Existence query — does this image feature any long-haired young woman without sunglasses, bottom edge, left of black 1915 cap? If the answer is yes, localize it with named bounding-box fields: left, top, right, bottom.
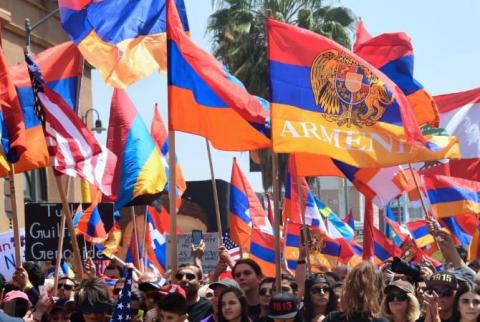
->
left=218, top=287, right=250, bottom=322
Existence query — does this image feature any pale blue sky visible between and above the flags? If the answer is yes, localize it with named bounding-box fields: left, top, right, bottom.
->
left=92, top=0, right=480, bottom=191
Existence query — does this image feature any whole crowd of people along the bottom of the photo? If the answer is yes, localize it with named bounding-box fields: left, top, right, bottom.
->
left=0, top=226, right=480, bottom=322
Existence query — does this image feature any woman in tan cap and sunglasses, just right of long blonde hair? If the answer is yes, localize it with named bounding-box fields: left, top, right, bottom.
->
left=381, top=280, right=420, bottom=322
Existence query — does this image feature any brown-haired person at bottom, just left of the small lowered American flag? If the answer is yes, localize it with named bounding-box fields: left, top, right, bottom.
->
left=75, top=277, right=114, bottom=322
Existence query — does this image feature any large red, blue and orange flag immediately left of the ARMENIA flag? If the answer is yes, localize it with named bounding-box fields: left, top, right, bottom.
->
left=168, top=0, right=270, bottom=151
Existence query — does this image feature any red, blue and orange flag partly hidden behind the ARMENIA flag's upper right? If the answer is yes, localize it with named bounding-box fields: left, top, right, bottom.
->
left=353, top=20, right=439, bottom=127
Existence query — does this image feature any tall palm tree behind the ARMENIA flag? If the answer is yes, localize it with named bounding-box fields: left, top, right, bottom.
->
left=207, top=0, right=355, bottom=190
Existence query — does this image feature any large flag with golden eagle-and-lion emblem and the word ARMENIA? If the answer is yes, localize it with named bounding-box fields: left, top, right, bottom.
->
left=267, top=19, right=459, bottom=168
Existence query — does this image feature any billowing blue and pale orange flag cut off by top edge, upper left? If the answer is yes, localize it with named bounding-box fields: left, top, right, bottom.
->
left=58, top=0, right=188, bottom=88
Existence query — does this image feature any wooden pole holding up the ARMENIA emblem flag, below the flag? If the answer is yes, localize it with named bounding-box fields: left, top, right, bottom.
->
left=272, top=150, right=282, bottom=292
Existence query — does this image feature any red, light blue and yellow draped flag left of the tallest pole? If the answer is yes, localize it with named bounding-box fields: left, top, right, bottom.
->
left=107, top=89, right=167, bottom=209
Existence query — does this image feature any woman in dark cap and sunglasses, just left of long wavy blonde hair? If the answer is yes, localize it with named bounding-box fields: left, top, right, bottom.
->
left=303, top=273, right=338, bottom=322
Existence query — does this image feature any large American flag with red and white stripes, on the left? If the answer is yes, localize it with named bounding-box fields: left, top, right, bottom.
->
left=25, top=54, right=117, bottom=196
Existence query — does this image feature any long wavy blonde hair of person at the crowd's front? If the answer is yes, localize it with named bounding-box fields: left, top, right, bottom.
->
left=340, top=262, right=381, bottom=319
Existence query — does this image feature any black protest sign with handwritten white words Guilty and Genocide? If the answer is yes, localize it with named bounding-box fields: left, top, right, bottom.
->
left=25, top=203, right=113, bottom=261
